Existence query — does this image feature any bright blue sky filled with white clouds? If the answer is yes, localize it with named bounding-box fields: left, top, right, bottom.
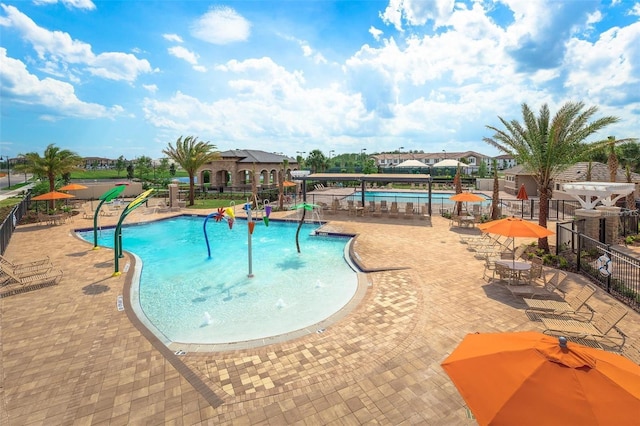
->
left=0, top=0, right=640, bottom=159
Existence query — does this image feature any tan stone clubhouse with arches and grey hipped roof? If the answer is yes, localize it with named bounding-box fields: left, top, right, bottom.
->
left=196, top=149, right=298, bottom=188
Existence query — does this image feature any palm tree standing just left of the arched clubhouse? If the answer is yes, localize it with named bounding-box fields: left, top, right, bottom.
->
left=162, top=136, right=220, bottom=206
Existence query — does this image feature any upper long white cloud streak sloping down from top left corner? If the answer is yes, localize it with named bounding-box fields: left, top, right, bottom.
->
left=0, top=4, right=152, bottom=82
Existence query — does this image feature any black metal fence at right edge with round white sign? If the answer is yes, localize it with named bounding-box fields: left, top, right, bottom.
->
left=556, top=220, right=640, bottom=312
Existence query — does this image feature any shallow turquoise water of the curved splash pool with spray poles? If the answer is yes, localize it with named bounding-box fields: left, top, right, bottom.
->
left=79, top=216, right=357, bottom=344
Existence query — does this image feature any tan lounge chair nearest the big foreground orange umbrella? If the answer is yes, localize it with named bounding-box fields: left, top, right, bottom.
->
left=541, top=302, right=628, bottom=351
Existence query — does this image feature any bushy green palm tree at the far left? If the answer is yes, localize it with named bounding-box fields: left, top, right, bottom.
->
left=16, top=144, right=82, bottom=209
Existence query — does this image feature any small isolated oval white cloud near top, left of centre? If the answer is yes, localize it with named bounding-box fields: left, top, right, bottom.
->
left=191, top=7, right=251, bottom=44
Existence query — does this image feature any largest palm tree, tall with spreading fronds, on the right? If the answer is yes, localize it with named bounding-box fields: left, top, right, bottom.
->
left=483, top=102, right=619, bottom=252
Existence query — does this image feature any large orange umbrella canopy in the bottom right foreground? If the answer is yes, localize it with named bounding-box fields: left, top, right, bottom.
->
left=442, top=332, right=640, bottom=425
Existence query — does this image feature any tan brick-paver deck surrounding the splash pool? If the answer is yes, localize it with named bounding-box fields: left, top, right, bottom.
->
left=0, top=202, right=640, bottom=426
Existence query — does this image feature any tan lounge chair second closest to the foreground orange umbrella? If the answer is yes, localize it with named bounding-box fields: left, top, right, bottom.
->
left=524, top=282, right=596, bottom=320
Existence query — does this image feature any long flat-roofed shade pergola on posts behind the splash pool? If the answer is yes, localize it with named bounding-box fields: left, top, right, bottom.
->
left=294, top=173, right=431, bottom=215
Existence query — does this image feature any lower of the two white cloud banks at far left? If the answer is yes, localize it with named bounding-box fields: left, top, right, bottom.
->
left=0, top=47, right=123, bottom=118
